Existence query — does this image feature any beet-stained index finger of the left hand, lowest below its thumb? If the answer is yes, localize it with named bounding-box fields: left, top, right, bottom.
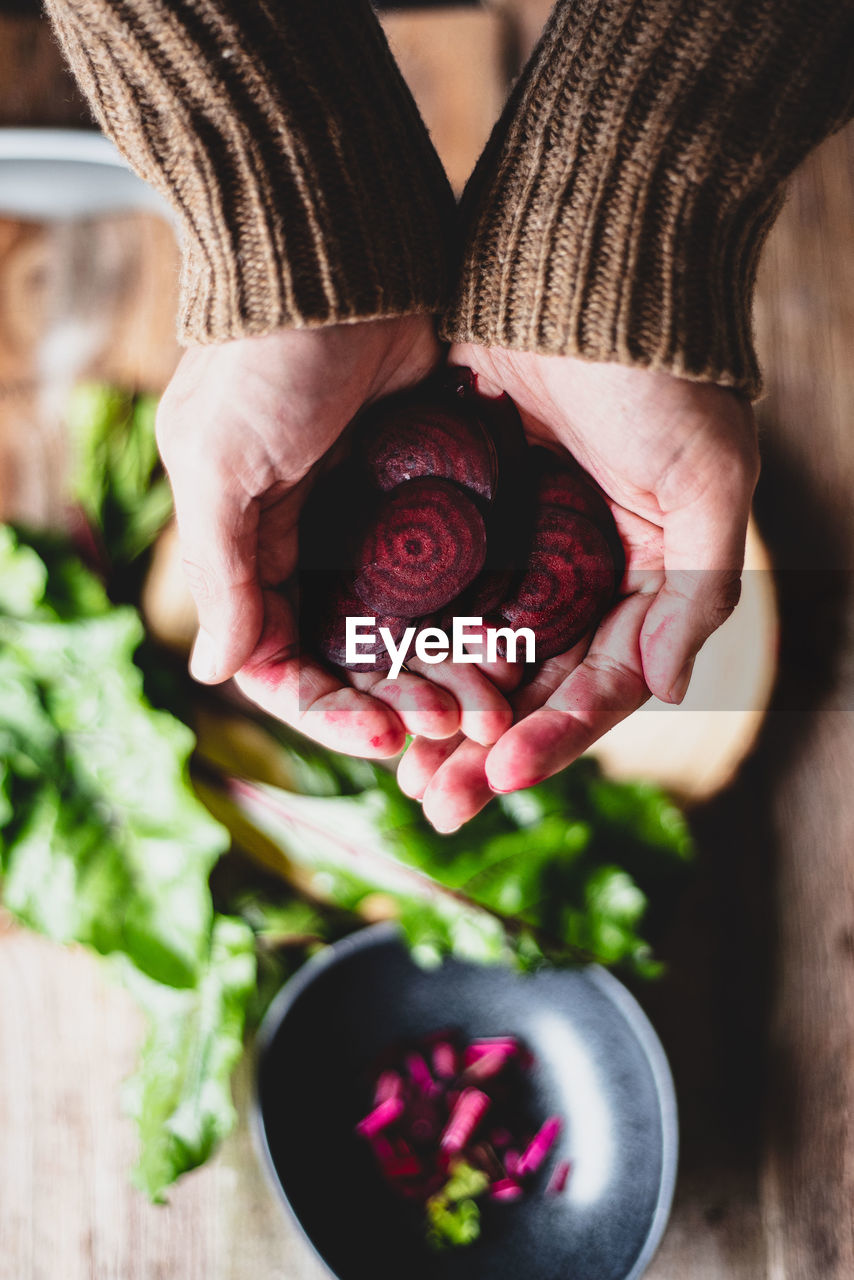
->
left=234, top=591, right=406, bottom=759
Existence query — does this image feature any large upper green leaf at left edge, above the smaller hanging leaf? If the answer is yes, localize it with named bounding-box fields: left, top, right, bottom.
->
left=0, top=535, right=228, bottom=986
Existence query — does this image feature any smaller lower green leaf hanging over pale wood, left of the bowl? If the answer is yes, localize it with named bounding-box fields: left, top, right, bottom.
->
left=123, top=916, right=256, bottom=1202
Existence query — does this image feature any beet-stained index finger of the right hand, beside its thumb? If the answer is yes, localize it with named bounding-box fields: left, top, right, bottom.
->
left=485, top=595, right=649, bottom=792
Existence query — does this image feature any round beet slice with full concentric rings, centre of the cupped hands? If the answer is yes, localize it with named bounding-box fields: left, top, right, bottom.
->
left=355, top=479, right=487, bottom=618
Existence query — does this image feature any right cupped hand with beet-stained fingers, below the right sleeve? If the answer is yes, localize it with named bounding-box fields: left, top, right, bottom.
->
left=398, top=346, right=758, bottom=832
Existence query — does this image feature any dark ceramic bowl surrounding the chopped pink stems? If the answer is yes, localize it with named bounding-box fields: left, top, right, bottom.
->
left=250, top=925, right=677, bottom=1280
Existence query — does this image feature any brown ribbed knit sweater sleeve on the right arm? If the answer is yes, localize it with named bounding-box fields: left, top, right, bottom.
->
left=443, top=0, right=854, bottom=396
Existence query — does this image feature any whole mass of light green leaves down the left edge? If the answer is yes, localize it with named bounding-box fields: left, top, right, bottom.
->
left=0, top=526, right=256, bottom=1199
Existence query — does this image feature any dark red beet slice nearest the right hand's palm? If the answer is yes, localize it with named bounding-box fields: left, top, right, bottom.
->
left=498, top=507, right=617, bottom=662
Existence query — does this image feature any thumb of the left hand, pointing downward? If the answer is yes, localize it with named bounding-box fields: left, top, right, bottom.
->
left=170, top=466, right=264, bottom=685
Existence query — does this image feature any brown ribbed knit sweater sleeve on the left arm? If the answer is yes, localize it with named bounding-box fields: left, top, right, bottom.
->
left=41, top=0, right=453, bottom=342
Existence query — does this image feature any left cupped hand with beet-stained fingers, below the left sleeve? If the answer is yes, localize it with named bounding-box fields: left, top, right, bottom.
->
left=157, top=316, right=510, bottom=756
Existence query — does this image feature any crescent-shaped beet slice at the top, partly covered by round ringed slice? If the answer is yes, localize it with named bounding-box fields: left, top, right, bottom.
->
left=359, top=392, right=497, bottom=502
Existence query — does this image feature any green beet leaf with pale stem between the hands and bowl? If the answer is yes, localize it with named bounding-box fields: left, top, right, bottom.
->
left=218, top=727, right=691, bottom=975
